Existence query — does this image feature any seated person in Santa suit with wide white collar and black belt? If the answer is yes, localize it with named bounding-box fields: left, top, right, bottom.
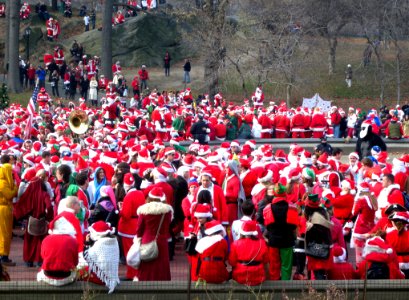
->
left=192, top=221, right=229, bottom=283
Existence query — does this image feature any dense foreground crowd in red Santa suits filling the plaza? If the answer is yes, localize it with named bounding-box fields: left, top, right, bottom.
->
left=0, top=96, right=409, bottom=291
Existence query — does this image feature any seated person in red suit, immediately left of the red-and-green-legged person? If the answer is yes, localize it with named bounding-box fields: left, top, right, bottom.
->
left=229, top=221, right=268, bottom=286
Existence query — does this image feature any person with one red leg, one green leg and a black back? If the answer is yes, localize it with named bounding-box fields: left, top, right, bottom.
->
left=263, top=183, right=299, bottom=280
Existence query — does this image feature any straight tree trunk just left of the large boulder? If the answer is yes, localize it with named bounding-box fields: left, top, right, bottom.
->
left=101, top=0, right=113, bottom=80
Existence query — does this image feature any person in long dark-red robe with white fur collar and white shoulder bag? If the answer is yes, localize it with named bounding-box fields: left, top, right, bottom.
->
left=134, top=187, right=173, bottom=281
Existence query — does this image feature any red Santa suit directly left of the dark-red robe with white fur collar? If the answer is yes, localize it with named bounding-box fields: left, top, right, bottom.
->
left=118, top=189, right=146, bottom=279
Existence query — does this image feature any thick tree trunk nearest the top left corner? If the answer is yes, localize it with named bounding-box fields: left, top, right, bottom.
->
left=7, top=0, right=21, bottom=93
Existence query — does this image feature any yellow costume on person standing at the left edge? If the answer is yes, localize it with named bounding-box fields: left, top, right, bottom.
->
left=0, top=164, right=17, bottom=256
